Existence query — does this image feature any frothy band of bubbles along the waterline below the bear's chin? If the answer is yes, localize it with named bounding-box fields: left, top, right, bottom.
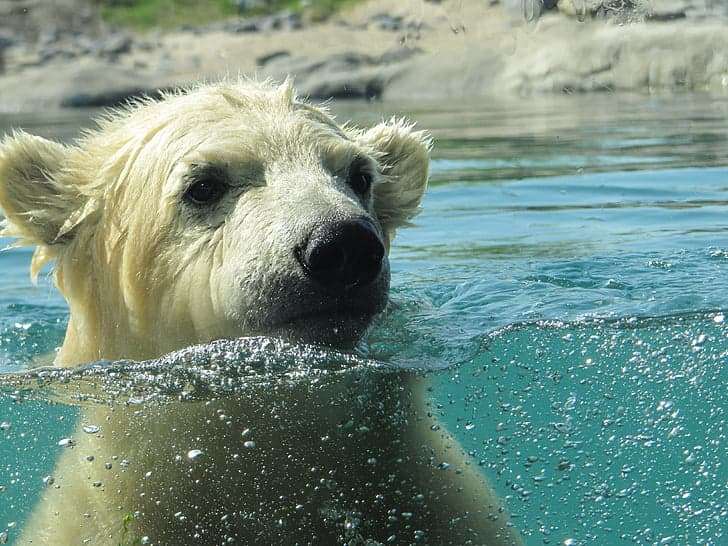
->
left=0, top=337, right=387, bottom=405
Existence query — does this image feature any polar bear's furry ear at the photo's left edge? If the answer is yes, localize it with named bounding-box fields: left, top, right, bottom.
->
left=0, top=131, right=79, bottom=246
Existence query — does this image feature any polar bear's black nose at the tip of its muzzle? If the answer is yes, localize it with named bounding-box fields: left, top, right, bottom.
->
left=298, top=219, right=384, bottom=288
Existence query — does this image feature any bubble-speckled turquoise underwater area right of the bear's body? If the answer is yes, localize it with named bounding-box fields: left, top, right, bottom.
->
left=436, top=311, right=728, bottom=544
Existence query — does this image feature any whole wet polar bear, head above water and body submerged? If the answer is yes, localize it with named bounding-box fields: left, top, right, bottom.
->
left=0, top=80, right=519, bottom=545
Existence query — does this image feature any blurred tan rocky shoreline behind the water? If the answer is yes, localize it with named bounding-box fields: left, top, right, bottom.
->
left=0, top=0, right=728, bottom=112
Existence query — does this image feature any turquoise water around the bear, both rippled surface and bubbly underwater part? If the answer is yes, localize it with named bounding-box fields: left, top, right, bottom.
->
left=0, top=96, right=728, bottom=545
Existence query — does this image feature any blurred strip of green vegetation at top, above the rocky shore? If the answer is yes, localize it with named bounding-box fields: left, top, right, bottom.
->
left=96, top=0, right=361, bottom=30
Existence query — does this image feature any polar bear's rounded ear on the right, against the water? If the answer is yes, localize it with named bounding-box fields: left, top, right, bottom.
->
left=359, top=119, right=432, bottom=238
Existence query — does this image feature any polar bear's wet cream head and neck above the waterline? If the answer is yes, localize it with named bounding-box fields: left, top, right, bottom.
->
left=0, top=81, right=430, bottom=364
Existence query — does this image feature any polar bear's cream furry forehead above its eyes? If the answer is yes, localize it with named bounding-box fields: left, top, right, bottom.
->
left=79, top=86, right=370, bottom=202
